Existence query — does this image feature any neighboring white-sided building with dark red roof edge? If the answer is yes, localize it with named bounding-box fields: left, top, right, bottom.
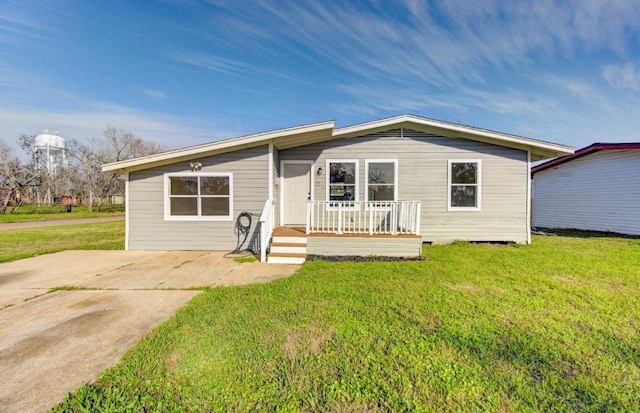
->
left=531, top=143, right=640, bottom=235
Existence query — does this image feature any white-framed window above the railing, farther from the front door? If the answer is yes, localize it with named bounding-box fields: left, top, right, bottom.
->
left=365, top=159, right=398, bottom=201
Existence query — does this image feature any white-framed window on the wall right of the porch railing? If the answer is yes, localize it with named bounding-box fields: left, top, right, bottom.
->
left=448, top=160, right=481, bottom=211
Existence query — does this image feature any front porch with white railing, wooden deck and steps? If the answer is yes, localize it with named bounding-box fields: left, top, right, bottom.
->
left=260, top=201, right=422, bottom=264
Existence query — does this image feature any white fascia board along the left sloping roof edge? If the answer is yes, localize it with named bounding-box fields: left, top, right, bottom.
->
left=102, top=121, right=335, bottom=172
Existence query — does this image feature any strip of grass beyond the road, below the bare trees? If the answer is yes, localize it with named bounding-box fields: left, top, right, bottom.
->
left=0, top=205, right=124, bottom=225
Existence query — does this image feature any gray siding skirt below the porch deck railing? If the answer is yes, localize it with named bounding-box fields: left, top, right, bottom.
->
left=307, top=235, right=422, bottom=257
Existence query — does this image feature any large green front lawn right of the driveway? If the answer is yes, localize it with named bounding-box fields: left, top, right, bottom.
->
left=54, top=237, right=640, bottom=412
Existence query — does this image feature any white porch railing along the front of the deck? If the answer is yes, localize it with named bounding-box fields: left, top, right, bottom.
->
left=307, top=201, right=421, bottom=235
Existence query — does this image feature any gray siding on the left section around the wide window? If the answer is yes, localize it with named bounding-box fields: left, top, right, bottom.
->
left=128, top=145, right=271, bottom=251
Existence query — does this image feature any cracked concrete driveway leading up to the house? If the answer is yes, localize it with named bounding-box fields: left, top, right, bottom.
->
left=0, top=251, right=299, bottom=412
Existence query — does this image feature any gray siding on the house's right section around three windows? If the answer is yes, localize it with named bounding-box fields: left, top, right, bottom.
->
left=280, top=129, right=529, bottom=243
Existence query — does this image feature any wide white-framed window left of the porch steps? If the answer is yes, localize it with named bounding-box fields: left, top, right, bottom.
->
left=164, top=173, right=233, bottom=221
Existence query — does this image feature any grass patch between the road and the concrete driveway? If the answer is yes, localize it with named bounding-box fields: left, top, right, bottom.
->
left=0, top=221, right=124, bottom=263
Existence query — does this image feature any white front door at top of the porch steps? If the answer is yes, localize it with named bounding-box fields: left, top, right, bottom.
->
left=282, top=162, right=311, bottom=225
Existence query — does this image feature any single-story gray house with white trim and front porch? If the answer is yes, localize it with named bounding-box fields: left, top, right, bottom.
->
left=102, top=115, right=573, bottom=262
